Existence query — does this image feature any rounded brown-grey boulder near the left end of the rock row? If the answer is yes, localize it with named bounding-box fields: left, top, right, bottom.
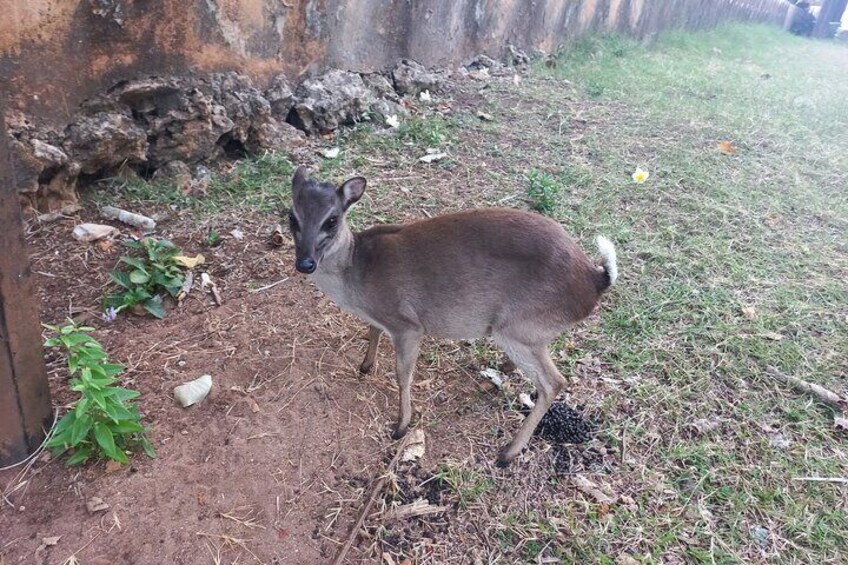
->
left=63, top=112, right=148, bottom=174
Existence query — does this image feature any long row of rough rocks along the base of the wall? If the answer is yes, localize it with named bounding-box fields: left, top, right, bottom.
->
left=7, top=49, right=527, bottom=212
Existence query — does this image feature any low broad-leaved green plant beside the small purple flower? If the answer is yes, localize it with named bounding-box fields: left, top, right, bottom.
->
left=103, top=238, right=183, bottom=318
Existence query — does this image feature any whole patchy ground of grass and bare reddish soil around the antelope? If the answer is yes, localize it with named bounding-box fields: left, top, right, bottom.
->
left=0, top=26, right=848, bottom=565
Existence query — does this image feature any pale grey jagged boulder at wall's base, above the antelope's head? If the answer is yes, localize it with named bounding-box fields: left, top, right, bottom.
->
left=288, top=69, right=374, bottom=133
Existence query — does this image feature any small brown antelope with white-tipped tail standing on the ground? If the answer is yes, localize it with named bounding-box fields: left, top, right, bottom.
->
left=289, top=167, right=618, bottom=467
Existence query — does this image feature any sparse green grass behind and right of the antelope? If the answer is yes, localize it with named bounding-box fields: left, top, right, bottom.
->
left=93, top=25, right=848, bottom=564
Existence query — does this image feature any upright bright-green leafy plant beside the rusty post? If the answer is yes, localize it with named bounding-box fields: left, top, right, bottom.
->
left=44, top=323, right=156, bottom=465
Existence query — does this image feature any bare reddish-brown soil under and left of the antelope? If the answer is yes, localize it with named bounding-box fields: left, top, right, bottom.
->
left=0, top=75, right=617, bottom=565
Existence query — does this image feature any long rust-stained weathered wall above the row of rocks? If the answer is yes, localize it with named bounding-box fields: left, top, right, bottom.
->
left=0, top=0, right=786, bottom=122
